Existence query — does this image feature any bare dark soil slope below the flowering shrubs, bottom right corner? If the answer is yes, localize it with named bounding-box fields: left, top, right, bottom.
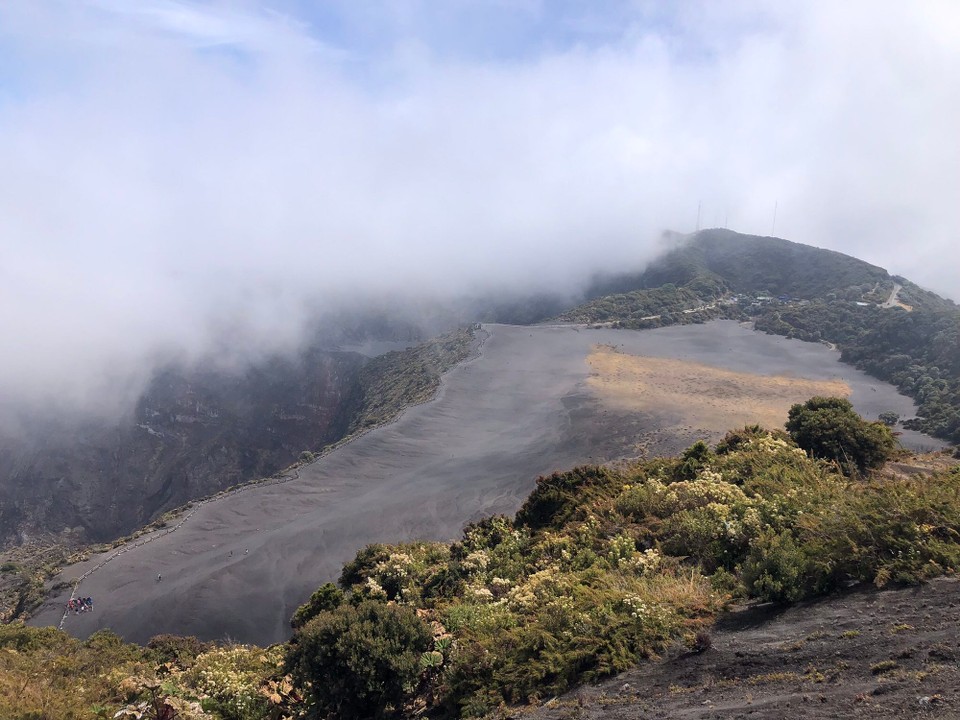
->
left=513, top=579, right=960, bottom=720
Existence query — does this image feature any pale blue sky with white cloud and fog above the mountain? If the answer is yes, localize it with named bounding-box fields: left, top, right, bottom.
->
left=0, top=0, right=960, bottom=420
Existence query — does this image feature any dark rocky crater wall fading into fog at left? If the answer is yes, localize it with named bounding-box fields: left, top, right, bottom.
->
left=0, top=350, right=366, bottom=543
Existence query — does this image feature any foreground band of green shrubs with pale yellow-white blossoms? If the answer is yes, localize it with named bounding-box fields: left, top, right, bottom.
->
left=9, top=414, right=960, bottom=720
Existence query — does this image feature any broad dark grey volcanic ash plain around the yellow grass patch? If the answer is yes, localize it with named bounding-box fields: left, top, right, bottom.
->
left=31, top=321, right=940, bottom=644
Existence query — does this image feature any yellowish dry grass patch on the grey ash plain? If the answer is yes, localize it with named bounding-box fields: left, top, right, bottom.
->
left=587, top=345, right=850, bottom=432
